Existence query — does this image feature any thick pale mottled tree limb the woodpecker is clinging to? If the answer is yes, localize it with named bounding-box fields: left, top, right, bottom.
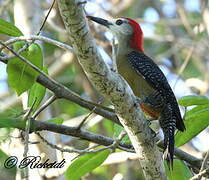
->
left=57, top=0, right=166, bottom=180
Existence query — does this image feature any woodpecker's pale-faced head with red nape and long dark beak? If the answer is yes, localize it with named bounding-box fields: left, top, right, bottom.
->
left=87, top=16, right=144, bottom=52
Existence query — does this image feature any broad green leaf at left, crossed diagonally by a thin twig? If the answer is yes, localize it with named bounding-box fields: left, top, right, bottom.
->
left=7, top=41, right=43, bottom=96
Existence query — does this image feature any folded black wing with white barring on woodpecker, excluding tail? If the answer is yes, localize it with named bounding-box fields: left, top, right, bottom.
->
left=127, top=51, right=185, bottom=131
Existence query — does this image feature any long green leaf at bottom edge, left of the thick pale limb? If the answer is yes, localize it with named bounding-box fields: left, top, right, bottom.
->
left=65, top=149, right=111, bottom=180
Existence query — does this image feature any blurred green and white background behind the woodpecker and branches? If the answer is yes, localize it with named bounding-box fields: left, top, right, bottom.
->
left=0, top=0, right=209, bottom=180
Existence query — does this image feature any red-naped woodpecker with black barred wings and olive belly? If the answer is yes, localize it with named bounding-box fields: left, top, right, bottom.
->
left=87, top=16, right=186, bottom=166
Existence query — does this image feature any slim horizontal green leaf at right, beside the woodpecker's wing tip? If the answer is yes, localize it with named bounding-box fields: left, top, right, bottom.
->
left=178, top=95, right=209, bottom=107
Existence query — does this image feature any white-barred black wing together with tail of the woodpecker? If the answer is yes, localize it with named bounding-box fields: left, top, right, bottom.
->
left=128, top=51, right=185, bottom=166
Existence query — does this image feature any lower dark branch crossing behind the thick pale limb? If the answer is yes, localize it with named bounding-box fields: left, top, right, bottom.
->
left=0, top=117, right=202, bottom=169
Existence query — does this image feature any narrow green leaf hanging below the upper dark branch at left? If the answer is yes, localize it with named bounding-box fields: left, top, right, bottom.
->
left=28, top=67, right=48, bottom=110
